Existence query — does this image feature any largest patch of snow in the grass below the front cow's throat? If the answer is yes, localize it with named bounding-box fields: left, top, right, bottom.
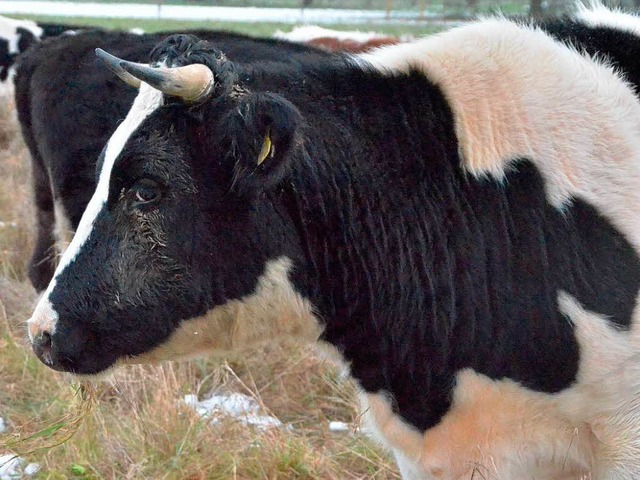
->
left=183, top=393, right=282, bottom=430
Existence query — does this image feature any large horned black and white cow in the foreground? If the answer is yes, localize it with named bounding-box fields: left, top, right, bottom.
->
left=28, top=15, right=640, bottom=480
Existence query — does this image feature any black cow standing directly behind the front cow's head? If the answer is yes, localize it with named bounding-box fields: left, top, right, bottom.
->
left=14, top=30, right=330, bottom=292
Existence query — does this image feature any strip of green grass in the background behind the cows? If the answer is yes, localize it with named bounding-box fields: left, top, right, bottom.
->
left=7, top=15, right=444, bottom=37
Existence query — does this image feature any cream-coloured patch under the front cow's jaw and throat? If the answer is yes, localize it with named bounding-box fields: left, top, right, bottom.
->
left=124, top=257, right=322, bottom=363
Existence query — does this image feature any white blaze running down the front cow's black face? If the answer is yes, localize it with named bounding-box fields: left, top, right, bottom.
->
left=28, top=83, right=163, bottom=339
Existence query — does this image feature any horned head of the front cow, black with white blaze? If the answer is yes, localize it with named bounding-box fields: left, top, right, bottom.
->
left=29, top=36, right=318, bottom=374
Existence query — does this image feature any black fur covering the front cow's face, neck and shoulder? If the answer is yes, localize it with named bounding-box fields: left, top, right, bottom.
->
left=38, top=37, right=640, bottom=430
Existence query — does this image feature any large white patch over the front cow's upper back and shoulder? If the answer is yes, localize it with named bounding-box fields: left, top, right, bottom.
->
left=356, top=18, right=640, bottom=255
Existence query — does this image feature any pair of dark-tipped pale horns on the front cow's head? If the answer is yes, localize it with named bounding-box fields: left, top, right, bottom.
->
left=96, top=49, right=213, bottom=102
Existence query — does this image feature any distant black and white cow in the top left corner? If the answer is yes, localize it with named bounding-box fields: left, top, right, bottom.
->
left=0, top=15, right=88, bottom=85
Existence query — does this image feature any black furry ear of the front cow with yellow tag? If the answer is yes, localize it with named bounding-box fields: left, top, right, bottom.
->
left=224, top=93, right=302, bottom=192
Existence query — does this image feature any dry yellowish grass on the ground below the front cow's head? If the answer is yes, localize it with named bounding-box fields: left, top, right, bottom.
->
left=0, top=92, right=398, bottom=480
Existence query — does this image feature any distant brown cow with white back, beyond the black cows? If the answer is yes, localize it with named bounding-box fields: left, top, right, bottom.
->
left=273, top=25, right=404, bottom=53
